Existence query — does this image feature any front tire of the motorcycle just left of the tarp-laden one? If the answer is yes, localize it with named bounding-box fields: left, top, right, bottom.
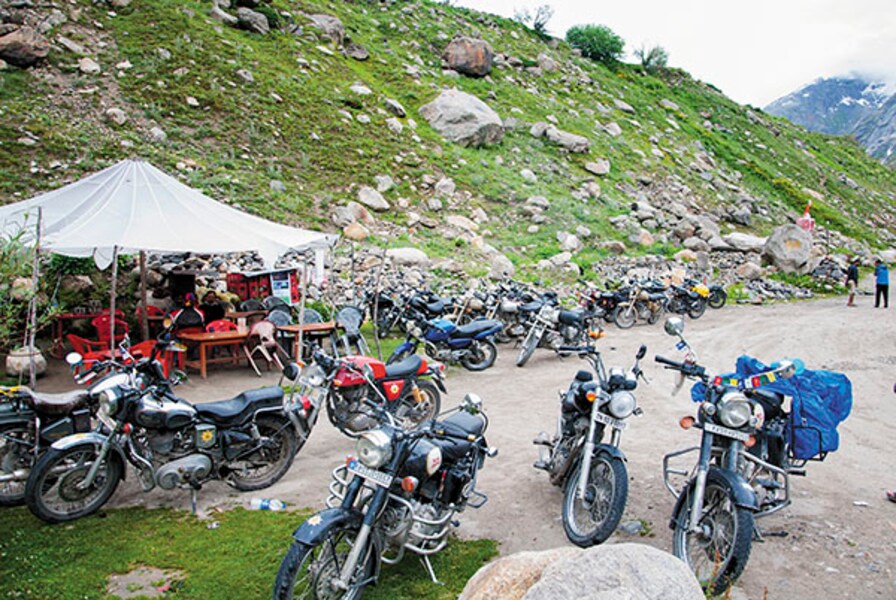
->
left=563, top=453, right=628, bottom=548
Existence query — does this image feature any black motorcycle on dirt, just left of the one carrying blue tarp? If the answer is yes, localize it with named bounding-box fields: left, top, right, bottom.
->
left=533, top=338, right=647, bottom=548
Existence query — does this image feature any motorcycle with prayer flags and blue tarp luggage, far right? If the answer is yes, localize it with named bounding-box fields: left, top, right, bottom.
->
left=656, top=317, right=851, bottom=594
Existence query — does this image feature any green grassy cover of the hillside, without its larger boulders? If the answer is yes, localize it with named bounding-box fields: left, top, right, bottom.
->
left=0, top=0, right=896, bottom=272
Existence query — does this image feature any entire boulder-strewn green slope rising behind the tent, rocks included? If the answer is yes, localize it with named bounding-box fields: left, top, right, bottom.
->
left=0, top=0, right=896, bottom=286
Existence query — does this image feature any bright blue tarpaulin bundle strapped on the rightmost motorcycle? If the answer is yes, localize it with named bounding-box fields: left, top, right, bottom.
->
left=691, top=355, right=852, bottom=460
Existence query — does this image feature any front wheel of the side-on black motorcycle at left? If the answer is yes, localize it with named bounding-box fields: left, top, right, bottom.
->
left=25, top=442, right=124, bottom=523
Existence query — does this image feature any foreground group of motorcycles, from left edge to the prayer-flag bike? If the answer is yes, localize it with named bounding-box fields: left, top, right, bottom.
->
left=0, top=294, right=844, bottom=598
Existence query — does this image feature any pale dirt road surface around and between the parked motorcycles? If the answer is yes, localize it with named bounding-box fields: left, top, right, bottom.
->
left=43, top=298, right=896, bottom=599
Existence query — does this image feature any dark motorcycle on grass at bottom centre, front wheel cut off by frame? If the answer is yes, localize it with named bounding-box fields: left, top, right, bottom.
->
left=273, top=394, right=497, bottom=599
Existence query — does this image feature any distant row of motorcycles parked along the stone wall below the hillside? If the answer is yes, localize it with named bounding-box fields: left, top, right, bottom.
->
left=365, top=279, right=727, bottom=371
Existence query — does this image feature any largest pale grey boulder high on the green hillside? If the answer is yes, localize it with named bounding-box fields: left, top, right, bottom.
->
left=420, top=89, right=504, bottom=146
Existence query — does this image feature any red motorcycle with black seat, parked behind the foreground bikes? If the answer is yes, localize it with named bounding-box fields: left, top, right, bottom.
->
left=298, top=350, right=446, bottom=437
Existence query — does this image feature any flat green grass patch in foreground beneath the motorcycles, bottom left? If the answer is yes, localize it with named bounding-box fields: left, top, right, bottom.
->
left=0, top=508, right=497, bottom=599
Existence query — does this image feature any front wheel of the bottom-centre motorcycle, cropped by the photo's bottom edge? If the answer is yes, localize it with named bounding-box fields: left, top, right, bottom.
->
left=274, top=527, right=379, bottom=600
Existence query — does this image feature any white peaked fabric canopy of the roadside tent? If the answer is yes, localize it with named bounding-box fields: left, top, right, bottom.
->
left=0, top=160, right=336, bottom=267
